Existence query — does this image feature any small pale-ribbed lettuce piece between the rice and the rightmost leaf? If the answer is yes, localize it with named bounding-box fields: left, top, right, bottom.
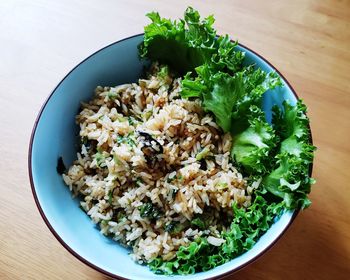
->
left=231, top=105, right=276, bottom=174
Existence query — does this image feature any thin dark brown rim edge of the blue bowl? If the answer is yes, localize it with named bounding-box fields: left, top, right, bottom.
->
left=28, top=33, right=313, bottom=280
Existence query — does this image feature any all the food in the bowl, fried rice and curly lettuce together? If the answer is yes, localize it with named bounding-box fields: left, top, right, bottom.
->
left=59, top=8, right=315, bottom=275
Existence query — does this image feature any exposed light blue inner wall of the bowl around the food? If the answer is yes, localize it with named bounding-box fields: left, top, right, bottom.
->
left=29, top=35, right=296, bottom=279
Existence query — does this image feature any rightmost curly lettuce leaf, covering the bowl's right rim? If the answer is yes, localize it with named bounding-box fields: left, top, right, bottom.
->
left=262, top=100, right=316, bottom=209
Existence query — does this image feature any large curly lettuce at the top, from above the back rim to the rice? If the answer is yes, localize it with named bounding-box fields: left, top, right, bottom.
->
left=139, top=7, right=281, bottom=132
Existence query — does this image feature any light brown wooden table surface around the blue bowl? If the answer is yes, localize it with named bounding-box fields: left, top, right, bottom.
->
left=0, top=0, right=350, bottom=280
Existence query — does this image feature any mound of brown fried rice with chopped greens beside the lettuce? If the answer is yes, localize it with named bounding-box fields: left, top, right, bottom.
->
left=63, top=65, right=258, bottom=263
